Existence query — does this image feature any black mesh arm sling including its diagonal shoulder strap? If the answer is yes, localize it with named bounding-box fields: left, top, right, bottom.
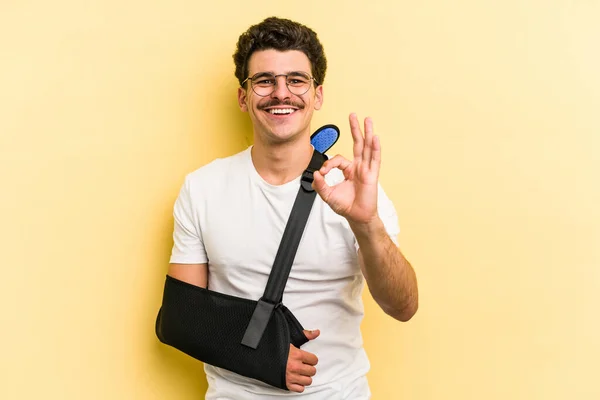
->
left=155, top=150, right=326, bottom=390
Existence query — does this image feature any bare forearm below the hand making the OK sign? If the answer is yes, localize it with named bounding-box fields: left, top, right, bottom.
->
left=350, top=218, right=418, bottom=321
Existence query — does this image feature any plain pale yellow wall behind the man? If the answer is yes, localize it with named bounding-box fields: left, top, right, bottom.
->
left=0, top=0, right=600, bottom=400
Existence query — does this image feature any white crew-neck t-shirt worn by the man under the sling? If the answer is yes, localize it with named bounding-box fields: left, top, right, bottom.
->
left=170, top=146, right=399, bottom=400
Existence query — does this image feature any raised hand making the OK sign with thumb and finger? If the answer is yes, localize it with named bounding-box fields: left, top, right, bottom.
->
left=313, top=113, right=381, bottom=223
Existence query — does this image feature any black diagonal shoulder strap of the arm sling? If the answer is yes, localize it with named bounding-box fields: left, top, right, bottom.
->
left=242, top=150, right=327, bottom=349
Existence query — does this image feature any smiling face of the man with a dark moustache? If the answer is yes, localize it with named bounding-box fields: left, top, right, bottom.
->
left=238, top=50, right=323, bottom=144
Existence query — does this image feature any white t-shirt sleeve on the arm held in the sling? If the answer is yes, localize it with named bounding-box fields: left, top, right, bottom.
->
left=170, top=176, right=208, bottom=264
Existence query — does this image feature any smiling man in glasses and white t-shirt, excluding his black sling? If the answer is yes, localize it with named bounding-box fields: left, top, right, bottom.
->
left=168, top=18, right=418, bottom=400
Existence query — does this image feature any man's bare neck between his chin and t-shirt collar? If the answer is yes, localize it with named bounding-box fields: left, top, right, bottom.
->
left=251, top=137, right=313, bottom=185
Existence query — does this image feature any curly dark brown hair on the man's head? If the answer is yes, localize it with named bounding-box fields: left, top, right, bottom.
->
left=233, top=17, right=327, bottom=86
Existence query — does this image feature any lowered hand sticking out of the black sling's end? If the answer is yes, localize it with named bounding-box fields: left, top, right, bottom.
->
left=285, top=330, right=321, bottom=393
